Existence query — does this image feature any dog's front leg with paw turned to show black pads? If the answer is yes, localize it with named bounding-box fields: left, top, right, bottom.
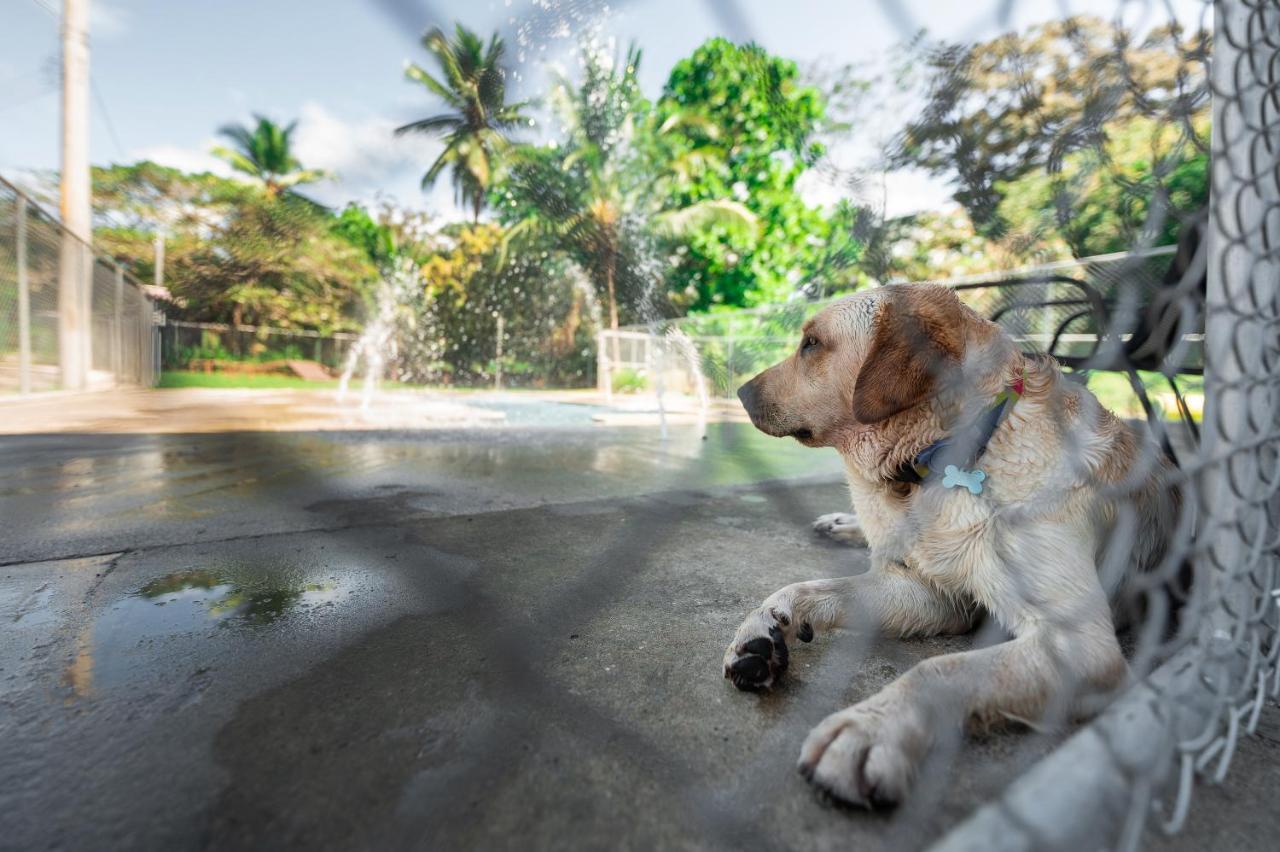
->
left=724, top=564, right=974, bottom=691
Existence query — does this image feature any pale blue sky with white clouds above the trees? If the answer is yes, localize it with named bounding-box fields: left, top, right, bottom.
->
left=0, top=0, right=1207, bottom=215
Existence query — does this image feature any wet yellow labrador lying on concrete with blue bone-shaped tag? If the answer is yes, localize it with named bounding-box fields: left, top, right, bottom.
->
left=724, top=285, right=1179, bottom=806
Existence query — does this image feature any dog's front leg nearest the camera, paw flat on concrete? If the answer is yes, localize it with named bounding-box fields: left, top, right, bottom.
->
left=799, top=532, right=1128, bottom=806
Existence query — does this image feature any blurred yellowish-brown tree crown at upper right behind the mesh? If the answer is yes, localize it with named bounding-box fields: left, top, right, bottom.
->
left=892, top=17, right=1208, bottom=238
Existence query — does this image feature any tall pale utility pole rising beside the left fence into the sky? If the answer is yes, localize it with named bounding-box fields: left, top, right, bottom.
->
left=58, top=0, right=93, bottom=390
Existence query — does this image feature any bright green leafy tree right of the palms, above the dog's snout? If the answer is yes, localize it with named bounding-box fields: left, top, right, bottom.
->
left=654, top=38, right=832, bottom=311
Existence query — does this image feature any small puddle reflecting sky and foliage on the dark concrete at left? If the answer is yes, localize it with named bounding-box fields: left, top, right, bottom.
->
left=80, top=565, right=353, bottom=695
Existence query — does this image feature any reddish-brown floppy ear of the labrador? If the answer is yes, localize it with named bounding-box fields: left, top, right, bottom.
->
left=854, top=285, right=964, bottom=423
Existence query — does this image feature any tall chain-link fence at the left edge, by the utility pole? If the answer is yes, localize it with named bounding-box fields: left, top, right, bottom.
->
left=0, top=179, right=159, bottom=394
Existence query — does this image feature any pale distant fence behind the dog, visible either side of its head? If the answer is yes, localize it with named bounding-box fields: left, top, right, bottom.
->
left=596, top=246, right=1177, bottom=398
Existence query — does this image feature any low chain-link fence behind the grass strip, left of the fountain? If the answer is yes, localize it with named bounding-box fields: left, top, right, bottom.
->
left=160, top=320, right=360, bottom=371
